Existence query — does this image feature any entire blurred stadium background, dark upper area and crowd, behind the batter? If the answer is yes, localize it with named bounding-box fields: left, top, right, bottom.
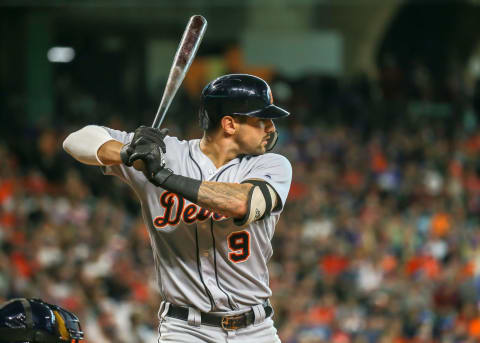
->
left=0, top=0, right=480, bottom=343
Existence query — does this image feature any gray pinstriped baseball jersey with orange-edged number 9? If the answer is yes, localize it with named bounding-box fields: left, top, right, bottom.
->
left=100, top=128, right=292, bottom=312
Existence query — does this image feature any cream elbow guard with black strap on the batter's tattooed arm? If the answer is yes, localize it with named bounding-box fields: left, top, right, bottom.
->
left=234, top=180, right=277, bottom=226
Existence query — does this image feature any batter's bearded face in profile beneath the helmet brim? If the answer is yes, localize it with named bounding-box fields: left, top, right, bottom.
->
left=237, top=117, right=275, bottom=155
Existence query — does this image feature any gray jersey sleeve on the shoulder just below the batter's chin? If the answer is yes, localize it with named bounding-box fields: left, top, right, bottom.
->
left=242, top=153, right=292, bottom=212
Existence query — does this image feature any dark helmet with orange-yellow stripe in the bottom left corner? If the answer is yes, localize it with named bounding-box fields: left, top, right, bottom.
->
left=0, top=298, right=83, bottom=343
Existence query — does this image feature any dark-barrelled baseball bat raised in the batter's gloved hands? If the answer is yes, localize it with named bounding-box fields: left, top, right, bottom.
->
left=133, top=15, right=207, bottom=170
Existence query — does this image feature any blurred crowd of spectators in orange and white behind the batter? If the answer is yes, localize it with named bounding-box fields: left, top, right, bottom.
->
left=0, top=59, right=480, bottom=343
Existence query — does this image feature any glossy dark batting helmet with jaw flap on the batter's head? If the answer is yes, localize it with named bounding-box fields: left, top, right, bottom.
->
left=199, top=74, right=290, bottom=150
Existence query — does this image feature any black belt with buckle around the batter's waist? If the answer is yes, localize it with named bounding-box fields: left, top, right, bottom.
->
left=167, top=304, right=273, bottom=330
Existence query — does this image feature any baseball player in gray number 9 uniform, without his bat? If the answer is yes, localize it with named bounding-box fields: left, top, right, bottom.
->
left=63, top=74, right=292, bottom=343
